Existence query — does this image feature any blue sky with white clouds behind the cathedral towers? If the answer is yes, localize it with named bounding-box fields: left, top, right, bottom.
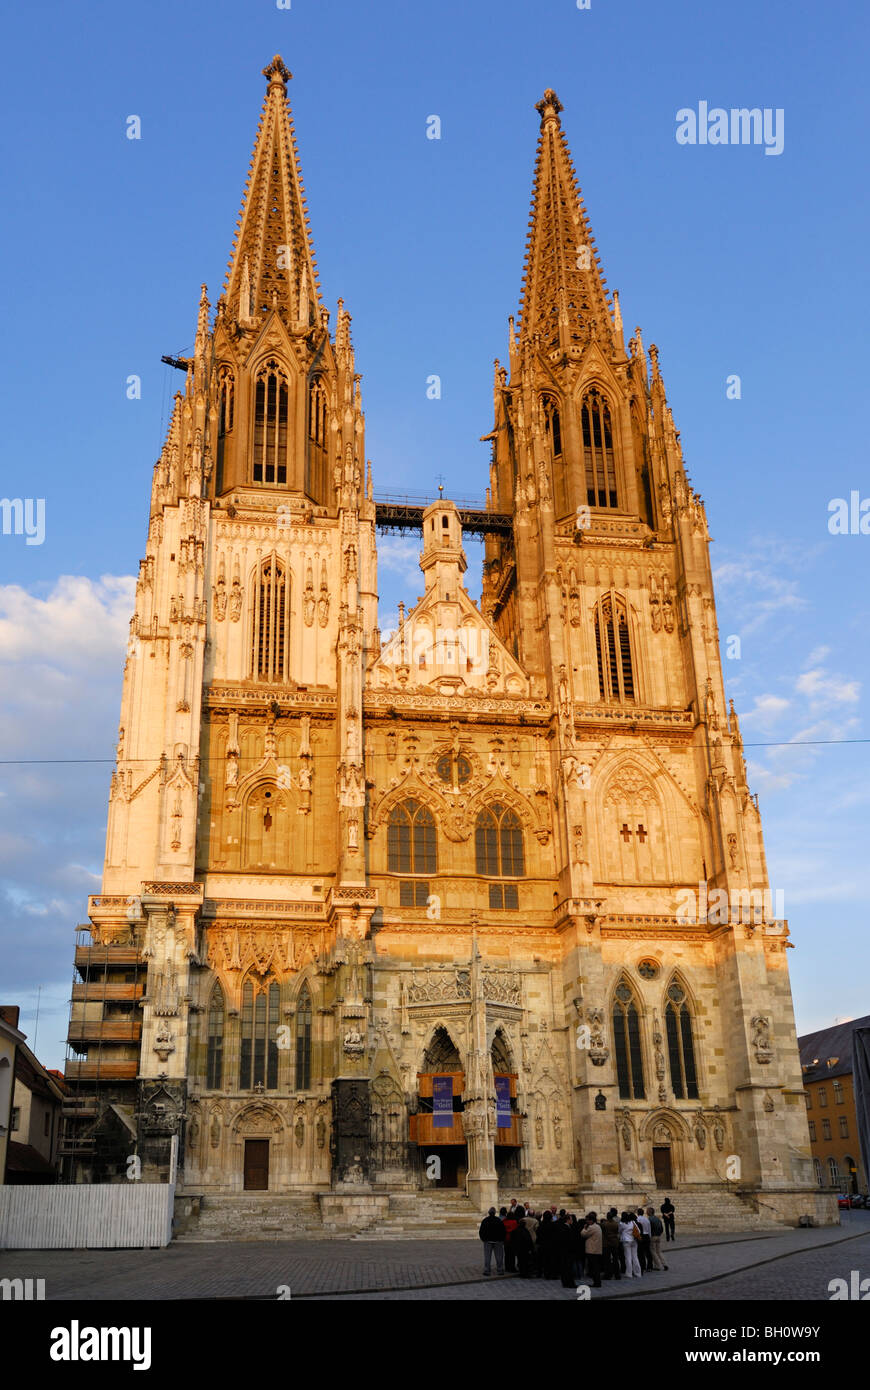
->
left=0, top=0, right=870, bottom=1065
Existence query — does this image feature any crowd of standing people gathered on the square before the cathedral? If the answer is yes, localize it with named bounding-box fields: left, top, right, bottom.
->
left=478, top=1197, right=675, bottom=1289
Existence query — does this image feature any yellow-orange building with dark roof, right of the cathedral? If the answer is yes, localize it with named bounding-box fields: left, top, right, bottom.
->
left=798, top=1015, right=870, bottom=1194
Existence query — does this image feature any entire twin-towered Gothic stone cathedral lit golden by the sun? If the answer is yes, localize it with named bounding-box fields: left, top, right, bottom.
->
left=65, top=57, right=827, bottom=1220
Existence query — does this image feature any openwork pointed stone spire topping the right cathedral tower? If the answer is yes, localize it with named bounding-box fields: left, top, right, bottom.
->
left=520, top=89, right=613, bottom=352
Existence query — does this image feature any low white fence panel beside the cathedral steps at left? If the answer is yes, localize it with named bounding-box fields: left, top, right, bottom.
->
left=0, top=1183, right=175, bottom=1250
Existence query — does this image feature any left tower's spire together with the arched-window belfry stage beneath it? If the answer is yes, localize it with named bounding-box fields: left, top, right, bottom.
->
left=203, top=57, right=364, bottom=513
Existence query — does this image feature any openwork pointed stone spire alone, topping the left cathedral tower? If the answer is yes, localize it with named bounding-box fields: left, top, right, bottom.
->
left=224, top=54, right=320, bottom=327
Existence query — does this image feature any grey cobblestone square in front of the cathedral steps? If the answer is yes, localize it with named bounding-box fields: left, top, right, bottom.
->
left=0, top=1212, right=870, bottom=1301
